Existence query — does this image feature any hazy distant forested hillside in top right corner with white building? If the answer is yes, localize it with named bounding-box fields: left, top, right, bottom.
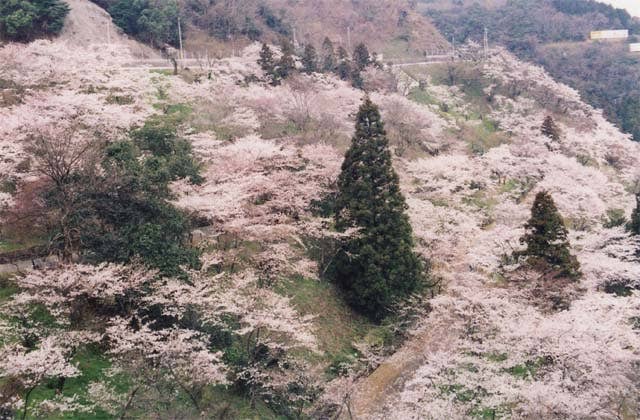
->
left=420, top=0, right=640, bottom=140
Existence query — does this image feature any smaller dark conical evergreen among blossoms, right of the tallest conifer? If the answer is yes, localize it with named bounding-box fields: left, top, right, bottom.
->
left=516, top=191, right=580, bottom=278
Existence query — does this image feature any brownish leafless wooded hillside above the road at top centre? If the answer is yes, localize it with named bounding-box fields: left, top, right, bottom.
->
left=89, top=0, right=448, bottom=59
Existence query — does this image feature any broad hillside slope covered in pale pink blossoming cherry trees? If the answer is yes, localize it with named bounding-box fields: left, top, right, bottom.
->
left=0, top=4, right=640, bottom=419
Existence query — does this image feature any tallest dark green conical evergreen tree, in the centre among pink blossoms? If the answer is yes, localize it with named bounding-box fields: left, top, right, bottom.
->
left=329, top=98, right=425, bottom=320
